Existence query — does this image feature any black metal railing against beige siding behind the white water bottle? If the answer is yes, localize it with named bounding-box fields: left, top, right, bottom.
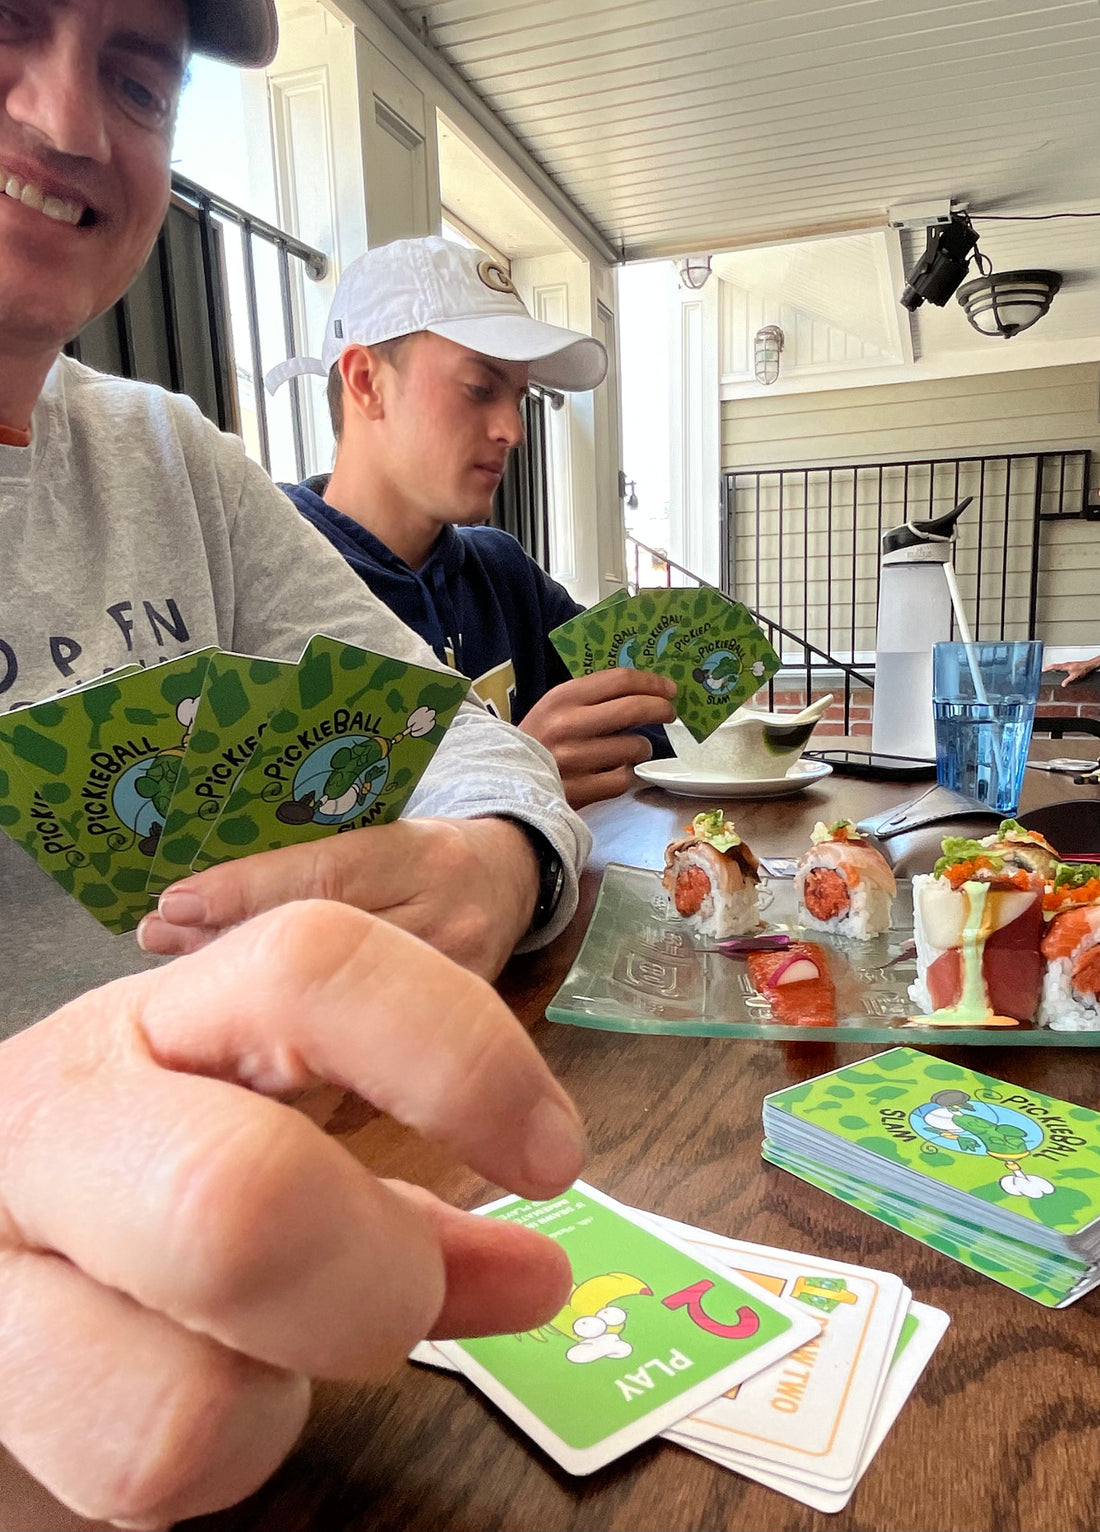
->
left=722, top=447, right=1092, bottom=662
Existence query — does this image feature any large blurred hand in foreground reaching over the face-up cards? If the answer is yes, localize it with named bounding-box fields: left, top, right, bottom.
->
left=0, top=902, right=584, bottom=1527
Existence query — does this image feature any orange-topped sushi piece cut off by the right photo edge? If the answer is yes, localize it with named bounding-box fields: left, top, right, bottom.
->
left=1039, top=863, right=1100, bottom=1033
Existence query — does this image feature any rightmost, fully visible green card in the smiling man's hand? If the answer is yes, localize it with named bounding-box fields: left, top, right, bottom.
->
left=192, top=637, right=469, bottom=872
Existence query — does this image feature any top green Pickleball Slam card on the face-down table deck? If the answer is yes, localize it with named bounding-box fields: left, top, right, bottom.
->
left=764, top=1048, right=1100, bottom=1236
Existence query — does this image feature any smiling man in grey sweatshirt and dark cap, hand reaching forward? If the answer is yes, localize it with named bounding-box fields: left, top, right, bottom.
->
left=0, top=0, right=587, bottom=1526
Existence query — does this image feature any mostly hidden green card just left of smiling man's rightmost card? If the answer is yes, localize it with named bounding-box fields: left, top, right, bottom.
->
left=146, top=653, right=294, bottom=895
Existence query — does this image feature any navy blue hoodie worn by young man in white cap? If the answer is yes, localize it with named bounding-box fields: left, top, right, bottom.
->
left=280, top=473, right=673, bottom=757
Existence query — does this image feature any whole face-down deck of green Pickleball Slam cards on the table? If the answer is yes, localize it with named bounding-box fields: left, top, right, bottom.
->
left=763, top=1048, right=1100, bottom=1308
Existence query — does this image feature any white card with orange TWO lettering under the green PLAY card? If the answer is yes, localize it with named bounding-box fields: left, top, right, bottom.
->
left=645, top=1215, right=910, bottom=1488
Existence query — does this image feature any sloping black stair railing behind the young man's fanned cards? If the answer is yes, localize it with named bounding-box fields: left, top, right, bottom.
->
left=627, top=536, right=875, bottom=734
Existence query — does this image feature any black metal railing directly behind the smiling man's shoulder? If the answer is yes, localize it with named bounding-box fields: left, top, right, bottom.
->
left=66, top=175, right=328, bottom=478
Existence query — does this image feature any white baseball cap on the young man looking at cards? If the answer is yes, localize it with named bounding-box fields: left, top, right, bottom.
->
left=267, top=234, right=607, bottom=394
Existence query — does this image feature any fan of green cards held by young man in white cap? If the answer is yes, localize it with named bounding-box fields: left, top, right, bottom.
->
left=550, top=585, right=780, bottom=741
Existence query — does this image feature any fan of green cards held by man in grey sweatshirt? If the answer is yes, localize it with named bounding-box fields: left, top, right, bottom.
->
left=0, top=636, right=469, bottom=931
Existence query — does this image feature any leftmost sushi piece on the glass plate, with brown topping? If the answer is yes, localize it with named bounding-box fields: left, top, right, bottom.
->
left=662, top=809, right=760, bottom=941
